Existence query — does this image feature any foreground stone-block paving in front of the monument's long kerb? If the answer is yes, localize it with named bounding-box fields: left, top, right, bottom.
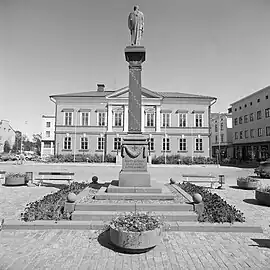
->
left=0, top=230, right=270, bottom=270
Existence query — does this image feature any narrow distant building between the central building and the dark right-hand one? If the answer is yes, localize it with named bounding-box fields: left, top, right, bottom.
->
left=211, top=113, right=233, bottom=160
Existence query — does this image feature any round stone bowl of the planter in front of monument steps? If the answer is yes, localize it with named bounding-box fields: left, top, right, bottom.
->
left=110, top=226, right=162, bottom=250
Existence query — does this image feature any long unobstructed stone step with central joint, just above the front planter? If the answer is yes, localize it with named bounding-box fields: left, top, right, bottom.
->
left=75, top=202, right=193, bottom=212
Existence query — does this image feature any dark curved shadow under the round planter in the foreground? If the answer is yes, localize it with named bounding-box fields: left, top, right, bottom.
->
left=97, top=229, right=153, bottom=255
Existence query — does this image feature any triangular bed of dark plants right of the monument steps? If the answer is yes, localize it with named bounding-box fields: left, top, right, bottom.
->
left=179, top=183, right=245, bottom=223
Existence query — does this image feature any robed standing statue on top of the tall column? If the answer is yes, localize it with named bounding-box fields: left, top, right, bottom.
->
left=128, top=6, right=144, bottom=46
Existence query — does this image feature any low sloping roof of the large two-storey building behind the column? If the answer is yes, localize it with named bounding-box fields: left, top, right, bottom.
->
left=50, top=87, right=217, bottom=99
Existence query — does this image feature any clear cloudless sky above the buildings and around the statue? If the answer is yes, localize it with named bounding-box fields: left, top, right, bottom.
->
left=0, top=0, right=270, bottom=137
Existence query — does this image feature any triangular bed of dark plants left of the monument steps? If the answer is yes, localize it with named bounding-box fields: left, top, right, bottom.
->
left=21, top=182, right=91, bottom=221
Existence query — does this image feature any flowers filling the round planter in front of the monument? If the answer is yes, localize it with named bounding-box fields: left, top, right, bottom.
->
left=110, top=212, right=163, bottom=232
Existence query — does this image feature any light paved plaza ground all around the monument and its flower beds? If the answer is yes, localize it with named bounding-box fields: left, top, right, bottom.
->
left=0, top=163, right=270, bottom=270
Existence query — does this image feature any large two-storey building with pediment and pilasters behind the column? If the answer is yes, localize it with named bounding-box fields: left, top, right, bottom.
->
left=50, top=85, right=216, bottom=157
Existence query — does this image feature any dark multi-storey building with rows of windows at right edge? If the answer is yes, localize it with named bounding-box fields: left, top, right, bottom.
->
left=231, top=86, right=270, bottom=160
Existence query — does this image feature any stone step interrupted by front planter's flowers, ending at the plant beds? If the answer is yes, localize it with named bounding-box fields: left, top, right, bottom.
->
left=72, top=211, right=198, bottom=222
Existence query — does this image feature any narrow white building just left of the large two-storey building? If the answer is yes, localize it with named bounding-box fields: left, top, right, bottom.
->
left=41, top=115, right=55, bottom=158
